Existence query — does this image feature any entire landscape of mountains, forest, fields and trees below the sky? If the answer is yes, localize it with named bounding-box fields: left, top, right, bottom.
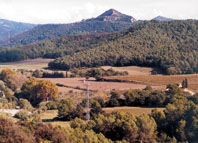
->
left=0, top=6, right=198, bottom=143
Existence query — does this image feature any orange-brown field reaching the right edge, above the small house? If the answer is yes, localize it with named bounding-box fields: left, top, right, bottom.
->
left=106, top=74, right=198, bottom=90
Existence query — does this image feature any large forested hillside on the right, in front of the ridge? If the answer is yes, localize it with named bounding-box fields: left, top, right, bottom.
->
left=49, top=20, right=198, bottom=74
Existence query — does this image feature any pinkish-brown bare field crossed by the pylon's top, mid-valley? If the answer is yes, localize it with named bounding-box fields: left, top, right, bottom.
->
left=43, top=78, right=165, bottom=93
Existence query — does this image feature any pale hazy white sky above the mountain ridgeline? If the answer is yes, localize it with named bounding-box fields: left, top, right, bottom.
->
left=0, top=0, right=198, bottom=24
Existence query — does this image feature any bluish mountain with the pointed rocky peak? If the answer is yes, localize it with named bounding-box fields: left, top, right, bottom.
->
left=0, top=9, right=136, bottom=47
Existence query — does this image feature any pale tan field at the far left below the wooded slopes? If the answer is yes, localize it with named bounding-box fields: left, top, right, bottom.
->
left=0, top=58, right=53, bottom=70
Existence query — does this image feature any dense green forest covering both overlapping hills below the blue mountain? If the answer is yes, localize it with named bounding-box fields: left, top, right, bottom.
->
left=0, top=20, right=198, bottom=74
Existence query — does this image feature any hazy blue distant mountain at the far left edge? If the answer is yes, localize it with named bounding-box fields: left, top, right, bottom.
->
left=0, top=19, right=35, bottom=40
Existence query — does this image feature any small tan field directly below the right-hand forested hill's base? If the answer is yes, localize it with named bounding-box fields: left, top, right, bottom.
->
left=101, top=66, right=161, bottom=75
